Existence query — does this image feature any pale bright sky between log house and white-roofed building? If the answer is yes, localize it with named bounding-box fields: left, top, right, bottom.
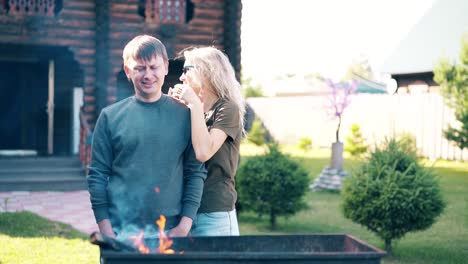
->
left=241, top=0, right=435, bottom=82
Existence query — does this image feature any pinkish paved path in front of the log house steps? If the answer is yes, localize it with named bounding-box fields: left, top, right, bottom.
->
left=0, top=191, right=98, bottom=234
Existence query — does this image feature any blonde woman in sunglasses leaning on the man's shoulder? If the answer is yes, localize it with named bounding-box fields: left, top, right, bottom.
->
left=169, top=47, right=245, bottom=236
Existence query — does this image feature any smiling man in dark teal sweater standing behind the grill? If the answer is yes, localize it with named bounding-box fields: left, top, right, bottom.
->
left=87, top=35, right=206, bottom=237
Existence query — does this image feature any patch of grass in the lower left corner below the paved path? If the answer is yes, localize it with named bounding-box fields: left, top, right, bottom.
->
left=0, top=211, right=99, bottom=264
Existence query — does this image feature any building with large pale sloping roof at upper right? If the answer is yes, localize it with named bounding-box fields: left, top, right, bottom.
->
left=380, top=0, right=468, bottom=93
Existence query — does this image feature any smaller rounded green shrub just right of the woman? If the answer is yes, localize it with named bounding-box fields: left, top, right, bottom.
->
left=236, top=144, right=309, bottom=229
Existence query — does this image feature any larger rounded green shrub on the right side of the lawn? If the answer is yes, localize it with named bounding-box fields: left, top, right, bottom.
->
left=342, top=139, right=445, bottom=254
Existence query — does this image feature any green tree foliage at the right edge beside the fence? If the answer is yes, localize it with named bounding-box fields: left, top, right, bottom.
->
left=434, top=34, right=468, bottom=151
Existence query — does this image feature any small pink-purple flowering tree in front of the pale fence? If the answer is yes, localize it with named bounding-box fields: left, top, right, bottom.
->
left=327, top=79, right=357, bottom=142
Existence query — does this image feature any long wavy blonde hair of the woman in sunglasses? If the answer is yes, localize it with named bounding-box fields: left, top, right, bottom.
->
left=183, top=47, right=246, bottom=134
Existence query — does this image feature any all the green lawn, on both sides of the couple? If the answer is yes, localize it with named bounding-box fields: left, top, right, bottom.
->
left=0, top=144, right=468, bottom=264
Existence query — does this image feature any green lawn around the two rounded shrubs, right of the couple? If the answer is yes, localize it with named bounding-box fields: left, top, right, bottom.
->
left=239, top=145, right=468, bottom=264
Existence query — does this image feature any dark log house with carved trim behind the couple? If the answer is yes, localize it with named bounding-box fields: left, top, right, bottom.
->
left=0, top=0, right=242, bottom=161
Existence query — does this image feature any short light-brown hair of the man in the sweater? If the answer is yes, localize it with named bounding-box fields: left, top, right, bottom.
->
left=122, top=35, right=169, bottom=65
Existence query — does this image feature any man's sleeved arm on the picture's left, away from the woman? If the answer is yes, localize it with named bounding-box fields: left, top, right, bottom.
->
left=87, top=112, right=115, bottom=237
